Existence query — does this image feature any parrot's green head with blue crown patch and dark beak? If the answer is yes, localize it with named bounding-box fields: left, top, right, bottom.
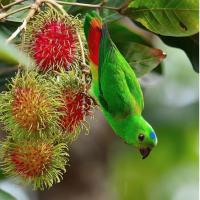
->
left=133, top=116, right=157, bottom=159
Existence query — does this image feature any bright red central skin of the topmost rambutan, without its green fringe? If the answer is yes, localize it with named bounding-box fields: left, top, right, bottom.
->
left=32, top=21, right=77, bottom=71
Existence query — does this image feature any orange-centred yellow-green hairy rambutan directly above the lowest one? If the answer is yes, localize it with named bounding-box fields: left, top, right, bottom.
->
left=0, top=71, right=62, bottom=137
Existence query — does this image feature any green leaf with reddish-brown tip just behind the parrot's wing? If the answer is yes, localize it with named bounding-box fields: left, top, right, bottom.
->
left=117, top=42, right=166, bottom=77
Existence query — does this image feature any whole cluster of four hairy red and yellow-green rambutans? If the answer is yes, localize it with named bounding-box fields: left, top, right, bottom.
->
left=0, top=9, right=94, bottom=189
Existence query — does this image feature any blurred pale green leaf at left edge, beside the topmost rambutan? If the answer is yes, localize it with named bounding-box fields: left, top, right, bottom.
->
left=0, top=35, right=33, bottom=68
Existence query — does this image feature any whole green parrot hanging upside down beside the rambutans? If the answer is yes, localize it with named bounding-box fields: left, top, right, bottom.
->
left=84, top=12, right=157, bottom=159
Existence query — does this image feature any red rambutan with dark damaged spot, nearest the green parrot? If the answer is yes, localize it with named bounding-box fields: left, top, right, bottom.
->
left=55, top=70, right=94, bottom=142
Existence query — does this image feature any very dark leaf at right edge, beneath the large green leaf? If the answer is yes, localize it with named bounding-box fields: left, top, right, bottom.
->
left=160, top=34, right=199, bottom=72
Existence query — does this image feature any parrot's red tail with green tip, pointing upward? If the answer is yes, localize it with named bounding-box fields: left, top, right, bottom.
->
left=84, top=11, right=103, bottom=66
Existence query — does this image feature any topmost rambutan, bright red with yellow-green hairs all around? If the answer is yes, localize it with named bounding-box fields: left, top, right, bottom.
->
left=23, top=10, right=82, bottom=71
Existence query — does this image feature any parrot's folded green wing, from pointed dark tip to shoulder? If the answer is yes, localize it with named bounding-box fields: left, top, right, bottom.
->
left=98, top=26, right=144, bottom=118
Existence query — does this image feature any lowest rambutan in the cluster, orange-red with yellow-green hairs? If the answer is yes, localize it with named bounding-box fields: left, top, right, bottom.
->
left=0, top=138, right=68, bottom=190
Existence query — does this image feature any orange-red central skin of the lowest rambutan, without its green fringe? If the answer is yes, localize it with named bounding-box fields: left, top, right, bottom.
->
left=9, top=143, right=52, bottom=178
